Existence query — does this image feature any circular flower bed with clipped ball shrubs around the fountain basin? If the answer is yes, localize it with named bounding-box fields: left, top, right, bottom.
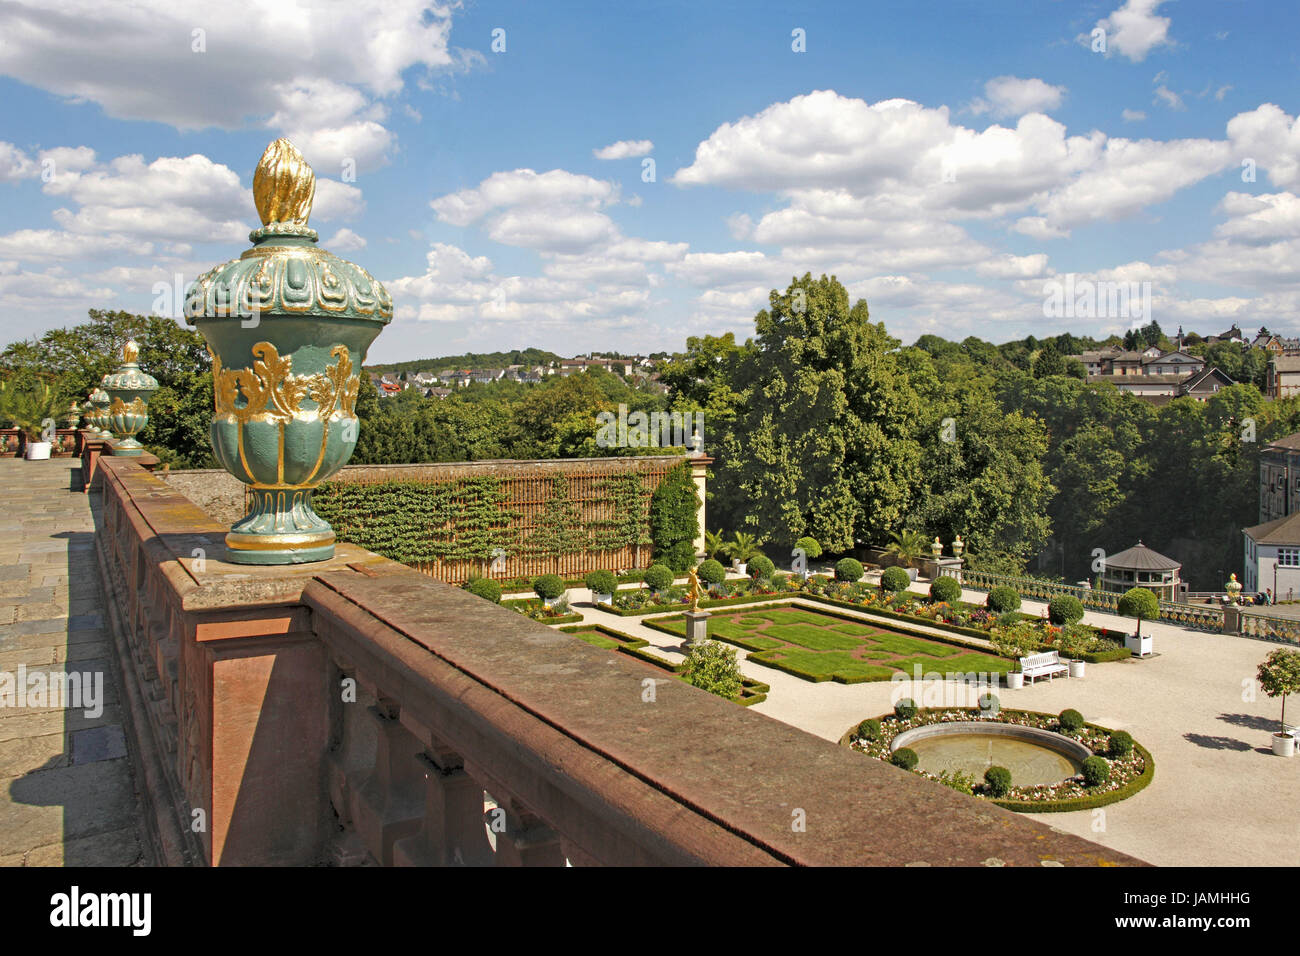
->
left=840, top=708, right=1156, bottom=813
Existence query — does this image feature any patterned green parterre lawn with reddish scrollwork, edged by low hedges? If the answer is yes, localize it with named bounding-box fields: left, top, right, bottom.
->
left=646, top=606, right=1011, bottom=683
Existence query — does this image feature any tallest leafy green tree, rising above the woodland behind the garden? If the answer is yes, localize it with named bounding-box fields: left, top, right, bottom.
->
left=712, top=273, right=920, bottom=551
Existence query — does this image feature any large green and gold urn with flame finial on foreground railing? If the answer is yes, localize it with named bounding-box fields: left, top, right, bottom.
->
left=185, top=139, right=393, bottom=564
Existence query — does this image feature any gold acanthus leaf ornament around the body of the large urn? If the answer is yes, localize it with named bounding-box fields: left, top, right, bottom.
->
left=209, top=342, right=361, bottom=424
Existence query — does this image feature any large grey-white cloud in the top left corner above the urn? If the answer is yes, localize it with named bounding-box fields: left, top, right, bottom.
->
left=0, top=0, right=477, bottom=165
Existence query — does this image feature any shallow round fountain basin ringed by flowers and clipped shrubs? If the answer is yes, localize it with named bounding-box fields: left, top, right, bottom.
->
left=889, top=721, right=1092, bottom=787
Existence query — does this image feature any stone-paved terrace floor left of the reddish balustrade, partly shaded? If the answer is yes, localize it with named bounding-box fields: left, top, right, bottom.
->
left=0, top=458, right=146, bottom=866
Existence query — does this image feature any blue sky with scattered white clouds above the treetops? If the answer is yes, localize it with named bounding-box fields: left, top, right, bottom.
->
left=0, top=0, right=1300, bottom=362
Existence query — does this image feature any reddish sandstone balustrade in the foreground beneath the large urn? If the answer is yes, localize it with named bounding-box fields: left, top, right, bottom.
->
left=92, top=457, right=1138, bottom=866
